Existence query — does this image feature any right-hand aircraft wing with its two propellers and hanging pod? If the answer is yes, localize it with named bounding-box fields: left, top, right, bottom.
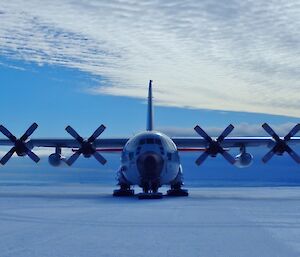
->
left=172, top=123, right=300, bottom=167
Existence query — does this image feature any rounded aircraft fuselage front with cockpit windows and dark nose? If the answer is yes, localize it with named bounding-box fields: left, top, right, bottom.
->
left=118, top=131, right=182, bottom=191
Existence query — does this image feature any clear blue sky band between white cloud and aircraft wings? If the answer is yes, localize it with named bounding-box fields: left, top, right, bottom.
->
left=0, top=56, right=298, bottom=137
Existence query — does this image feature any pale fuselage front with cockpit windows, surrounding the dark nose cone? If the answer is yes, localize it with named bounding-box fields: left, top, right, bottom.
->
left=119, top=131, right=182, bottom=186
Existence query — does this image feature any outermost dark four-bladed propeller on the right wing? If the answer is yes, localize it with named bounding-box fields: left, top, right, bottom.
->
left=262, top=123, right=300, bottom=163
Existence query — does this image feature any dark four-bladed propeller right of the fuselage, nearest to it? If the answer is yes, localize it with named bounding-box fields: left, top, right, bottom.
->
left=194, top=124, right=235, bottom=165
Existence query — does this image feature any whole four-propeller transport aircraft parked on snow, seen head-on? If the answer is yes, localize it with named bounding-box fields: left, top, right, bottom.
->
left=0, top=80, right=300, bottom=199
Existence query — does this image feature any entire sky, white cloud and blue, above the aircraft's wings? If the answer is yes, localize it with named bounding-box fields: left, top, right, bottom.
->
left=0, top=0, right=300, bottom=180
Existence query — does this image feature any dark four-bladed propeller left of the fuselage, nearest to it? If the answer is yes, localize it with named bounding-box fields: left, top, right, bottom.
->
left=66, top=125, right=106, bottom=166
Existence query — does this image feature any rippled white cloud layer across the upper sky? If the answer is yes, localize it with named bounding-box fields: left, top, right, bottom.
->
left=0, top=0, right=300, bottom=117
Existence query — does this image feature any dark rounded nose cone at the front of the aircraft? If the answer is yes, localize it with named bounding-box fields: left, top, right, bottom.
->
left=137, top=152, right=164, bottom=181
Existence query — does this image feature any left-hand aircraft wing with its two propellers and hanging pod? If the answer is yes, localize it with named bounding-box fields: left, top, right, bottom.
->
left=0, top=123, right=128, bottom=166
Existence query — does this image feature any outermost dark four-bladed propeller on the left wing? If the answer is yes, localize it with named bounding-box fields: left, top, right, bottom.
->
left=0, top=123, right=40, bottom=165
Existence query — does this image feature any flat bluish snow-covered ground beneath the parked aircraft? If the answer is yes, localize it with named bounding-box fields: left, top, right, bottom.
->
left=0, top=184, right=300, bottom=257
